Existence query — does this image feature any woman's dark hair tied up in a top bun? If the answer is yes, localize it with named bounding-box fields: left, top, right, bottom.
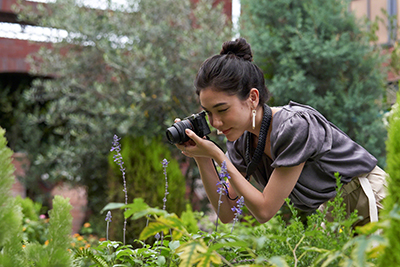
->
left=194, top=38, right=270, bottom=105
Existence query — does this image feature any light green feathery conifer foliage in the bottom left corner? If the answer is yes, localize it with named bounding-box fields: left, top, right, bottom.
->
left=0, top=128, right=76, bottom=267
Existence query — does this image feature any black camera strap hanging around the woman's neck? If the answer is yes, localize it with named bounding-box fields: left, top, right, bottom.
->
left=246, top=104, right=272, bottom=181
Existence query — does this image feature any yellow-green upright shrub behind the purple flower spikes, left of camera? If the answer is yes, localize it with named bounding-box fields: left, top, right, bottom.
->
left=107, top=136, right=185, bottom=245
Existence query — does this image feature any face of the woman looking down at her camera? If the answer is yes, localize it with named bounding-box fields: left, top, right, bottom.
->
left=199, top=88, right=251, bottom=141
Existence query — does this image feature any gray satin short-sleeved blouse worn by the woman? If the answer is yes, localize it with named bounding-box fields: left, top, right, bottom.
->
left=227, top=101, right=377, bottom=212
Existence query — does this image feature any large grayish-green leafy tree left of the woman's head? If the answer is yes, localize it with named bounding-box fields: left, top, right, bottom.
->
left=11, top=0, right=231, bottom=221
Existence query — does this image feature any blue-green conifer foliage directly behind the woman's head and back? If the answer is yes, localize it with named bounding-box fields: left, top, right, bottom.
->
left=240, top=0, right=387, bottom=166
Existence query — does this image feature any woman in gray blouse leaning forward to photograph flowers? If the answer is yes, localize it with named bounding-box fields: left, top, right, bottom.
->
left=177, top=38, right=385, bottom=225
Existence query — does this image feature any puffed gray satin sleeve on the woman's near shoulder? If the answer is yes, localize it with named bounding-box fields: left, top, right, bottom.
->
left=271, top=111, right=332, bottom=168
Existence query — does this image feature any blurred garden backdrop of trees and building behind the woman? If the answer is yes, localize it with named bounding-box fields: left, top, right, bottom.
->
left=0, top=0, right=400, bottom=244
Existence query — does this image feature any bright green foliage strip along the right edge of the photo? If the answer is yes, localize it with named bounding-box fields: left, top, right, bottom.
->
left=381, top=92, right=400, bottom=266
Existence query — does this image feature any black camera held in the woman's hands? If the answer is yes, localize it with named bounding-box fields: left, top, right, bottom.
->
left=166, top=111, right=211, bottom=144
